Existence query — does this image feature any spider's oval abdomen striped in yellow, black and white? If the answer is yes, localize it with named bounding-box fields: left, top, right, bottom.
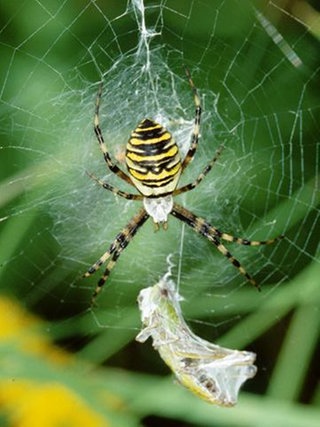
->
left=126, top=119, right=181, bottom=197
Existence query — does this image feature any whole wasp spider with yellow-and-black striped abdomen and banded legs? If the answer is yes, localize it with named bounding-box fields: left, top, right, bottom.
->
left=84, top=70, right=282, bottom=302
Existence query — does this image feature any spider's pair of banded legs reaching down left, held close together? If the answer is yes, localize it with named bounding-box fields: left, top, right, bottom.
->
left=83, top=209, right=149, bottom=303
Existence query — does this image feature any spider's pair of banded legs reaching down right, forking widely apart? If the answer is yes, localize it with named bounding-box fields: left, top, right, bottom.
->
left=171, top=203, right=283, bottom=289
